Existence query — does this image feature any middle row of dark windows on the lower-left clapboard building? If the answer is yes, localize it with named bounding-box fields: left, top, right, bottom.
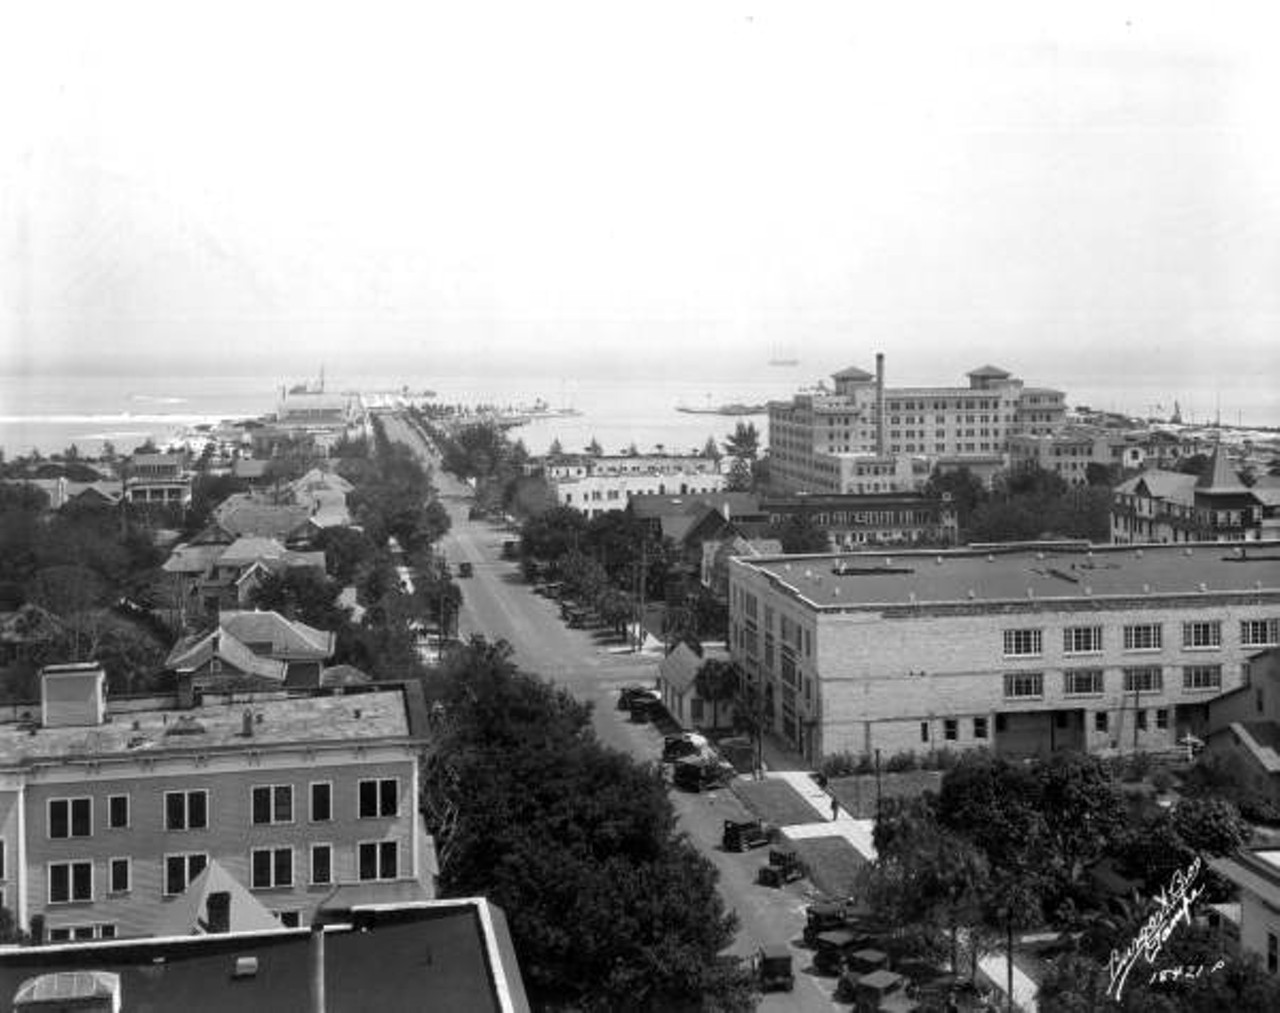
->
left=49, top=840, right=399, bottom=904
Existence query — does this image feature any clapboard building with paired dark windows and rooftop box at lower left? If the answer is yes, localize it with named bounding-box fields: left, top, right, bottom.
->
left=0, top=665, right=435, bottom=941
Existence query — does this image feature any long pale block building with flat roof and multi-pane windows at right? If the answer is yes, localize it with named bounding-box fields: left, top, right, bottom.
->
left=730, top=544, right=1280, bottom=762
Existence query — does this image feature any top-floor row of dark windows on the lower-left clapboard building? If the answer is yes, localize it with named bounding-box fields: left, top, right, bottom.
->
left=49, top=777, right=399, bottom=839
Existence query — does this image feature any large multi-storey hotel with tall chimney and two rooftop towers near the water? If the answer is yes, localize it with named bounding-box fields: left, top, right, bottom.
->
left=769, top=355, right=1066, bottom=492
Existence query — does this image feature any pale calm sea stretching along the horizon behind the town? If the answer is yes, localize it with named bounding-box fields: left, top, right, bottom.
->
left=0, top=366, right=1280, bottom=457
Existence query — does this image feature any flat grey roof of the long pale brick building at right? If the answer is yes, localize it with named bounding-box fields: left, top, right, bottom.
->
left=739, top=542, right=1280, bottom=608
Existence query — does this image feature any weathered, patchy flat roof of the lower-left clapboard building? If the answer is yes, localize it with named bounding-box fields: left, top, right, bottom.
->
left=0, top=688, right=410, bottom=766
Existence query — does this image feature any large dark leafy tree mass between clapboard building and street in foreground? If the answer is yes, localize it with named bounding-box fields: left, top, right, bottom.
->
left=422, top=638, right=754, bottom=1013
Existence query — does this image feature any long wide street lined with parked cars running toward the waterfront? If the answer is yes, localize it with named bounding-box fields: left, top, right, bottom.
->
left=383, top=416, right=837, bottom=1010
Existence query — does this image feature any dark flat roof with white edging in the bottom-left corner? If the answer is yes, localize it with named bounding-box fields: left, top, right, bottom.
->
left=0, top=887, right=530, bottom=1013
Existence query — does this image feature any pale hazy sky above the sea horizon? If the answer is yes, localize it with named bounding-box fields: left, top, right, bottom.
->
left=0, top=0, right=1280, bottom=399
